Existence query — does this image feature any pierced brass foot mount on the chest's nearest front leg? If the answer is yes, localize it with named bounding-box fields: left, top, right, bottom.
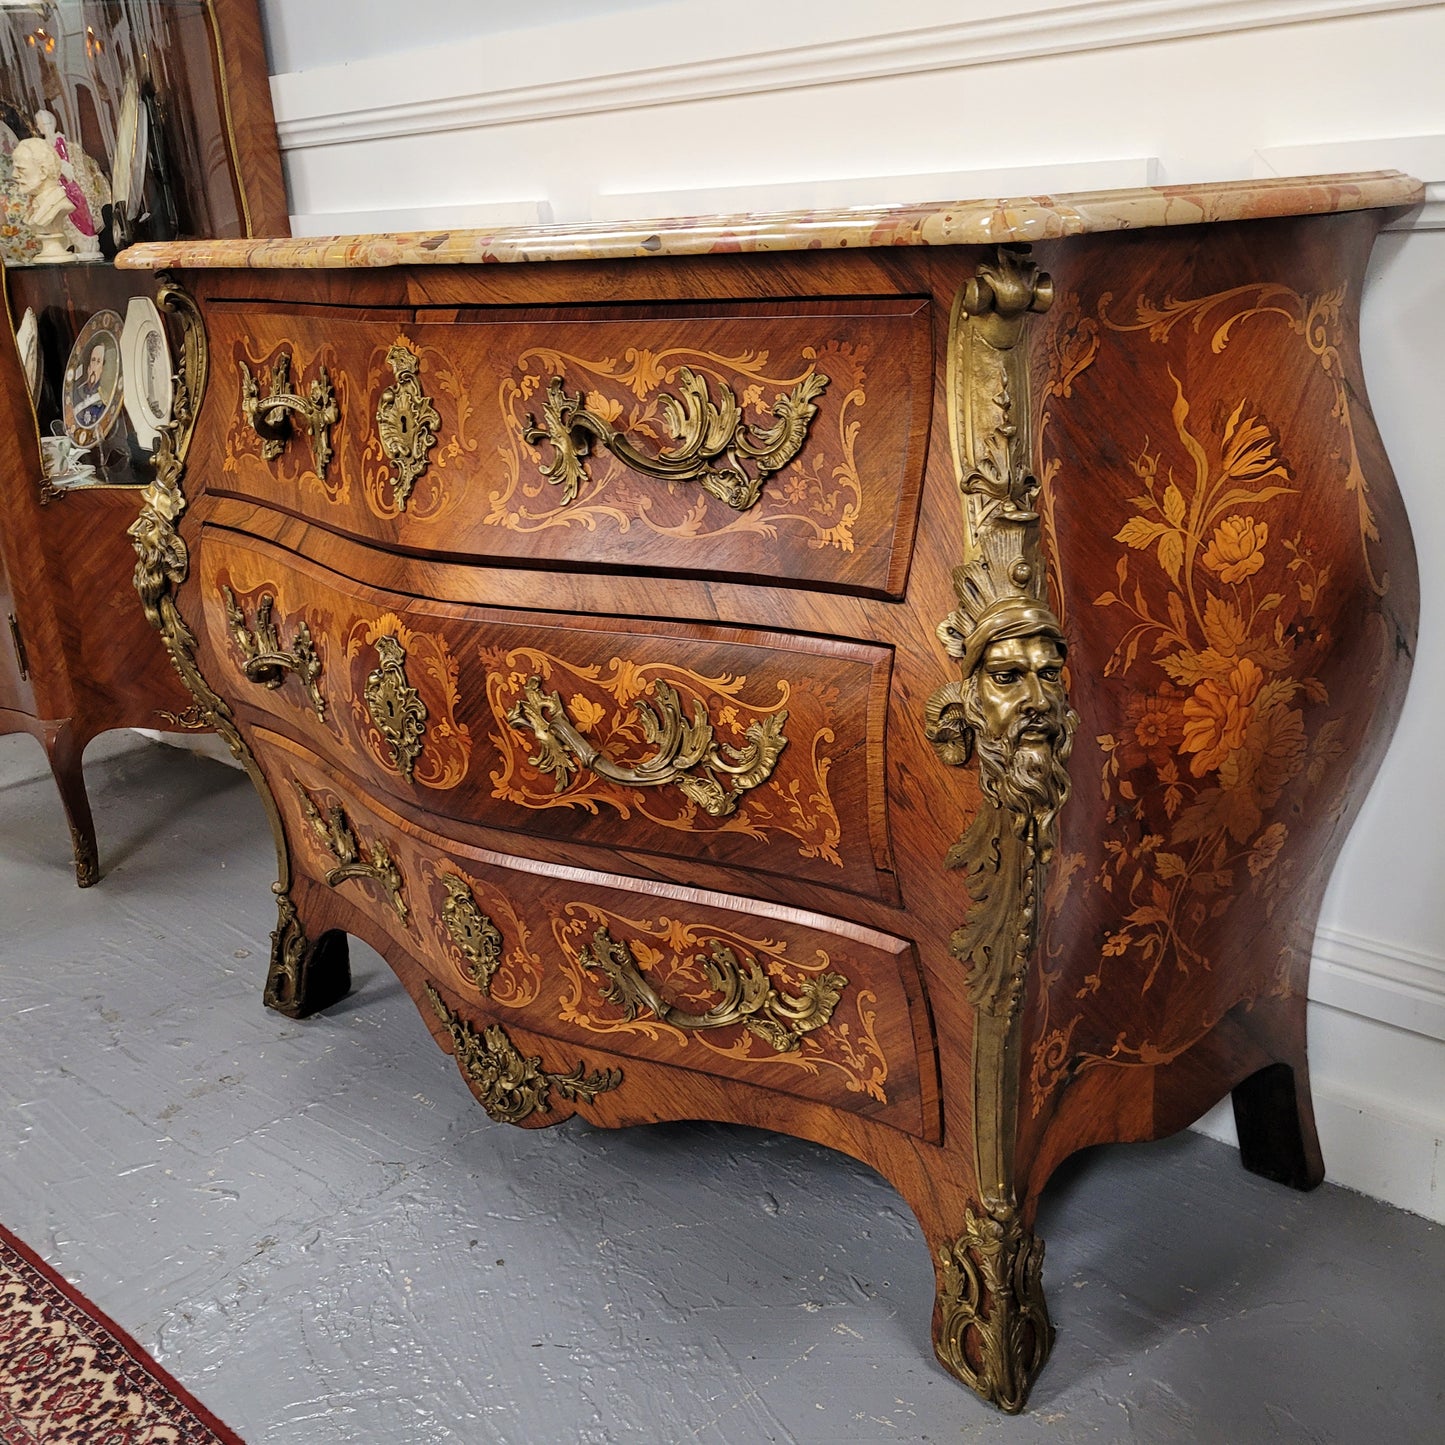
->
left=933, top=1202, right=1053, bottom=1415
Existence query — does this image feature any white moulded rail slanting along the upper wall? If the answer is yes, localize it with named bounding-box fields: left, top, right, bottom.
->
left=272, top=0, right=1419, bottom=149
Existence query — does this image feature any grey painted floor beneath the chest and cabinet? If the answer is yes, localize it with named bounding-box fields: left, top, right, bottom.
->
left=0, top=734, right=1445, bottom=1445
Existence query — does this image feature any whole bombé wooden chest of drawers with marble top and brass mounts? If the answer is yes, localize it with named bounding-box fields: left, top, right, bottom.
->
left=124, top=175, right=1416, bottom=1409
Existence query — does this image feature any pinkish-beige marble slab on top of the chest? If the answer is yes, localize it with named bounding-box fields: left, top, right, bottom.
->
left=116, top=171, right=1425, bottom=270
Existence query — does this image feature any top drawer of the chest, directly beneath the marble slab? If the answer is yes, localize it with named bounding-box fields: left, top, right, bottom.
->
left=210, top=298, right=932, bottom=597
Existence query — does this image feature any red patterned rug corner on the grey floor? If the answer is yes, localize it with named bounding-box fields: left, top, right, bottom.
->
left=0, top=1225, right=244, bottom=1445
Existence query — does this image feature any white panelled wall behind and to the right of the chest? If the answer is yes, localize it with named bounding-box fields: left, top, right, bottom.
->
left=254, top=0, right=1445, bottom=1220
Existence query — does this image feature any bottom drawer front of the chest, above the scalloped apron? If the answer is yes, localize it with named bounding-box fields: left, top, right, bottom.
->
left=257, top=730, right=938, bottom=1139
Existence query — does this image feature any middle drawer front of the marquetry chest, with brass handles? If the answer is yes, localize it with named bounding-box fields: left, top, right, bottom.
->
left=201, top=529, right=897, bottom=902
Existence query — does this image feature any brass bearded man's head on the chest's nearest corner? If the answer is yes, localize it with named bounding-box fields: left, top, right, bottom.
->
left=929, top=597, right=1079, bottom=861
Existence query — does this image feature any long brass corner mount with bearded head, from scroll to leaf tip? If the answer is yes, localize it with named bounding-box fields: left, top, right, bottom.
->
left=925, top=249, right=1078, bottom=1019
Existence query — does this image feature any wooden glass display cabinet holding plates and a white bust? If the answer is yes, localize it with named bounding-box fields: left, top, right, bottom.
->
left=0, top=0, right=289, bottom=886
